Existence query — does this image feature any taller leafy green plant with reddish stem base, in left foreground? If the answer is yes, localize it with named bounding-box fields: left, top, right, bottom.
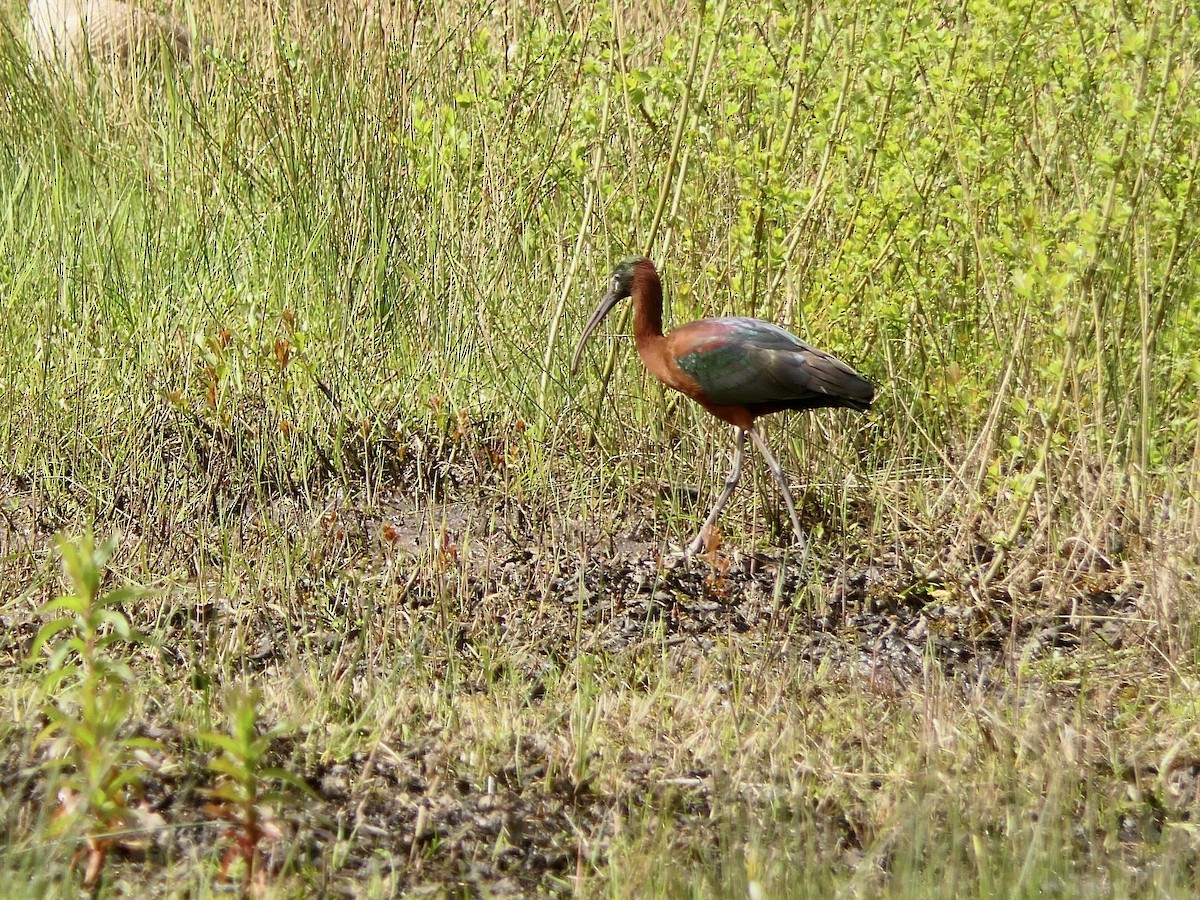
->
left=30, top=533, right=157, bottom=890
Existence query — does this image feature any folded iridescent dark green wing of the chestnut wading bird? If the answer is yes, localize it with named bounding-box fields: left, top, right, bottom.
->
left=671, top=318, right=874, bottom=406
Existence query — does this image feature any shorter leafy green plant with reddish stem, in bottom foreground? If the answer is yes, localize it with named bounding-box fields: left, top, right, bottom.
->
left=199, top=686, right=308, bottom=896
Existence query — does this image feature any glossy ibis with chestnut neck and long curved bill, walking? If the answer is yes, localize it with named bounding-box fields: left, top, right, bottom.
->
left=571, top=257, right=875, bottom=559
